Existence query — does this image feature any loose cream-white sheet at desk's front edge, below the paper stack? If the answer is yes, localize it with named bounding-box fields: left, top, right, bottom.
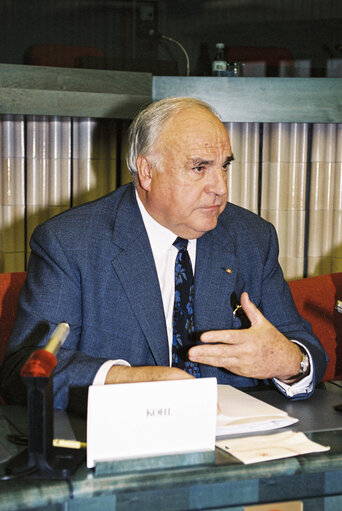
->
left=216, top=431, right=330, bottom=464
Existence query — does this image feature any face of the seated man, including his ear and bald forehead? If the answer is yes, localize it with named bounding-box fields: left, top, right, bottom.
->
left=137, top=106, right=232, bottom=239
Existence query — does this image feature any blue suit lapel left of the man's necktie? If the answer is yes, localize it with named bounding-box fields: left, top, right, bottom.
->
left=112, top=185, right=169, bottom=365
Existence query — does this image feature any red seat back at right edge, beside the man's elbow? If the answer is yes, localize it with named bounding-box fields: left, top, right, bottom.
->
left=289, top=272, right=342, bottom=381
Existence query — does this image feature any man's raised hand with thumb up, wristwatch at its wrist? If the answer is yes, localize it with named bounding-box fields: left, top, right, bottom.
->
left=188, top=292, right=302, bottom=383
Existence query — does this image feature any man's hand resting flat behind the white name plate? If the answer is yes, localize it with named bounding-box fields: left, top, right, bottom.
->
left=105, top=365, right=194, bottom=384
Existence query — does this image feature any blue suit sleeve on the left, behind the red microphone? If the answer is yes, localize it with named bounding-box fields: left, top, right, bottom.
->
left=0, top=224, right=105, bottom=412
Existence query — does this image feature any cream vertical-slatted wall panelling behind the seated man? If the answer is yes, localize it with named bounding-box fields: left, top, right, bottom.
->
left=0, top=115, right=342, bottom=279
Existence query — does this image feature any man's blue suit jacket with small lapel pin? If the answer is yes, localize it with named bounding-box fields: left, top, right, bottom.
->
left=1, top=184, right=326, bottom=414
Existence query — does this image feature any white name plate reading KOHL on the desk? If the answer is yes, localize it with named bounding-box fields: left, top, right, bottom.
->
left=87, top=378, right=217, bottom=468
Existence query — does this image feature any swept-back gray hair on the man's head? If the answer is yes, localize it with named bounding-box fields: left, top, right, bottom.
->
left=126, top=97, right=218, bottom=181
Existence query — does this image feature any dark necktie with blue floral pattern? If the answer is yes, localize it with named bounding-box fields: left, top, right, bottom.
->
left=172, top=238, right=200, bottom=378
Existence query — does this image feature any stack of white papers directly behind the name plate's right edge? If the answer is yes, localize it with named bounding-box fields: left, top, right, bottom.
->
left=216, top=385, right=298, bottom=437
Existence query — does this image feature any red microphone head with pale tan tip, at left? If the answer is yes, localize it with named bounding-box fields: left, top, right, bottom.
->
left=20, top=323, right=70, bottom=378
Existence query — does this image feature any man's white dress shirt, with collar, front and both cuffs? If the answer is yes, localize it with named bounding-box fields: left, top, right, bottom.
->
left=93, top=193, right=313, bottom=397
